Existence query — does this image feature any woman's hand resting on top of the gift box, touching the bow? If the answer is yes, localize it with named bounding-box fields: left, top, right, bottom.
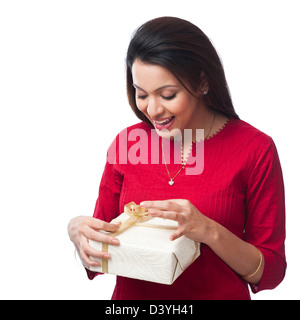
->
left=140, top=199, right=215, bottom=243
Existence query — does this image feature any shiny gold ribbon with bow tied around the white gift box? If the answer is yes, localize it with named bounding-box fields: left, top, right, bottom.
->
left=102, top=202, right=198, bottom=273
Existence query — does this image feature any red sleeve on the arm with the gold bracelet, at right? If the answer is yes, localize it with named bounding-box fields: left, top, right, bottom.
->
left=245, top=138, right=286, bottom=293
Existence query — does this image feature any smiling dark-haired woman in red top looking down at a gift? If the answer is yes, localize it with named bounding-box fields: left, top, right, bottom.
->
left=69, top=17, right=286, bottom=299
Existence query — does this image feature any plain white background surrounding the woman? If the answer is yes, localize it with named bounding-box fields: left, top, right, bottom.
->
left=0, top=0, right=300, bottom=299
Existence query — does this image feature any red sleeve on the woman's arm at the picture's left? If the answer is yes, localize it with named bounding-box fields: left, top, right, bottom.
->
left=86, top=141, right=123, bottom=280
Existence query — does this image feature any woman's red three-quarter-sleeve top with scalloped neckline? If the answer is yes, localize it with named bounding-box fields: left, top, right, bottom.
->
left=87, top=118, right=286, bottom=300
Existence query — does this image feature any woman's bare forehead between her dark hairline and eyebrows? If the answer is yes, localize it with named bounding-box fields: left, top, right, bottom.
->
left=132, top=60, right=180, bottom=92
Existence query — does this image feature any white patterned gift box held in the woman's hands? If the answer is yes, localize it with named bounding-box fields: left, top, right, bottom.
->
left=89, top=204, right=200, bottom=284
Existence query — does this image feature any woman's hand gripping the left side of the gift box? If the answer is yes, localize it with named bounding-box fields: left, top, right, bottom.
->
left=68, top=216, right=120, bottom=268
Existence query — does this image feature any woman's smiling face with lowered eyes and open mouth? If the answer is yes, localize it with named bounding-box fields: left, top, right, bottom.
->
left=132, top=60, right=203, bottom=138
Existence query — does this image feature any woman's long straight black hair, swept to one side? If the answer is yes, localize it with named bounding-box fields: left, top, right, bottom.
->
left=126, top=17, right=238, bottom=123
